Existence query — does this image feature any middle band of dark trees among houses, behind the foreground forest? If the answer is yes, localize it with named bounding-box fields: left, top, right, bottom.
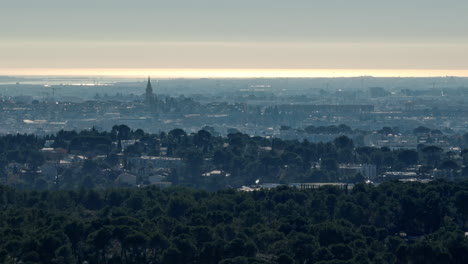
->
left=0, top=125, right=468, bottom=190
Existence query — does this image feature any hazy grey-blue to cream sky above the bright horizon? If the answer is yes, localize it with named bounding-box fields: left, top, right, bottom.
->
left=0, top=0, right=468, bottom=75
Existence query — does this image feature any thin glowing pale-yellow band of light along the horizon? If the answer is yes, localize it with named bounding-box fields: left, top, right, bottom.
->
left=0, top=68, right=468, bottom=79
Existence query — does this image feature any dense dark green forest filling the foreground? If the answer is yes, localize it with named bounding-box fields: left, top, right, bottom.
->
left=0, top=181, right=468, bottom=264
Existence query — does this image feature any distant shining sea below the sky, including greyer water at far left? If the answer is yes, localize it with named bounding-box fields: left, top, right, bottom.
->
left=0, top=68, right=468, bottom=86
